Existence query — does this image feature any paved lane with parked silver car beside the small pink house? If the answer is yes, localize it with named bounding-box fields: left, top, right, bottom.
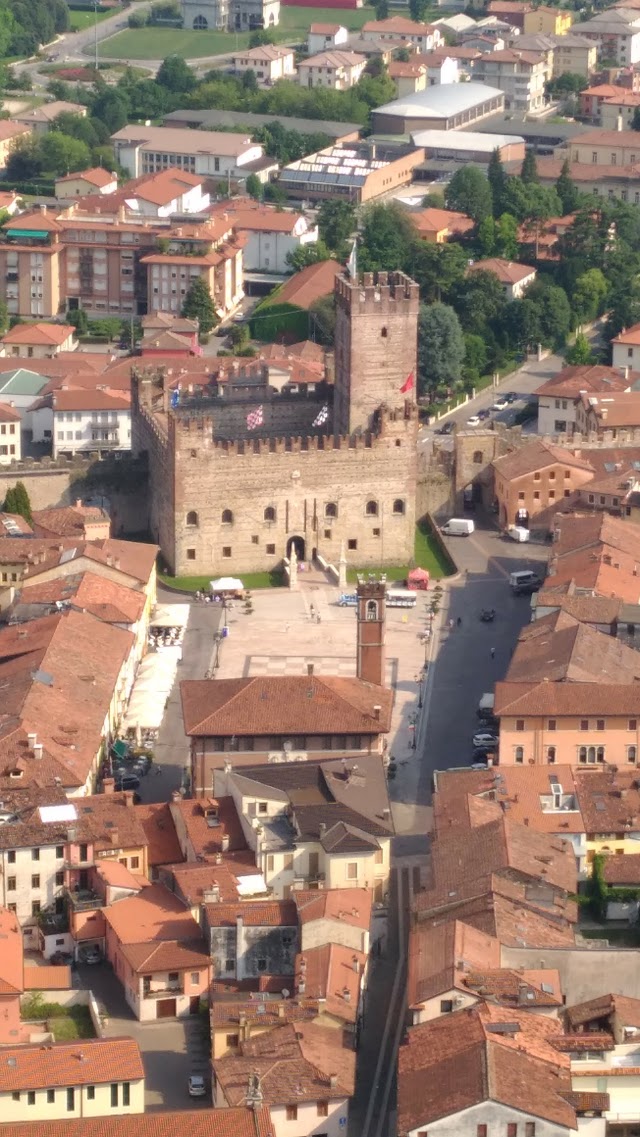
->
left=75, top=963, right=211, bottom=1113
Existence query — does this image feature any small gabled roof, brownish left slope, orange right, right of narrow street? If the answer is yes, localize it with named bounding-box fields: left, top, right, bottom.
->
left=407, top=920, right=500, bottom=1006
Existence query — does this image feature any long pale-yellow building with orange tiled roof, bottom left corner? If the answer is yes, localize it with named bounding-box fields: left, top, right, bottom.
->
left=0, top=1038, right=144, bottom=1124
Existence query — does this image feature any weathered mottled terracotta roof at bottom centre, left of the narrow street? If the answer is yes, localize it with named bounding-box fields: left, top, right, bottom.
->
left=214, top=1022, right=356, bottom=1106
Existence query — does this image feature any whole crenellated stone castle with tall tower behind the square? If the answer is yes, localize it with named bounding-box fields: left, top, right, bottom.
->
left=132, top=272, right=419, bottom=575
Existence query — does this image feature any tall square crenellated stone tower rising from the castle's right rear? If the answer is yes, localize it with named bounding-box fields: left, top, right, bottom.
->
left=334, top=273, right=419, bottom=434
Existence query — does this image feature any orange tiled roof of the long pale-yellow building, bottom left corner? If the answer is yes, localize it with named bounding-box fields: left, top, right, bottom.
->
left=0, top=1038, right=144, bottom=1094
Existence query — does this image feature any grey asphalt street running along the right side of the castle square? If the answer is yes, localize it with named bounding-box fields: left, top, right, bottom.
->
left=417, top=513, right=549, bottom=802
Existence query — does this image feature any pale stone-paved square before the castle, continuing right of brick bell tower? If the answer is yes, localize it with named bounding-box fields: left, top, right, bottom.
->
left=216, top=576, right=435, bottom=833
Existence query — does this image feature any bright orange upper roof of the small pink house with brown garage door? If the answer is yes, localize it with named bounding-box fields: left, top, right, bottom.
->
left=105, top=885, right=203, bottom=947
